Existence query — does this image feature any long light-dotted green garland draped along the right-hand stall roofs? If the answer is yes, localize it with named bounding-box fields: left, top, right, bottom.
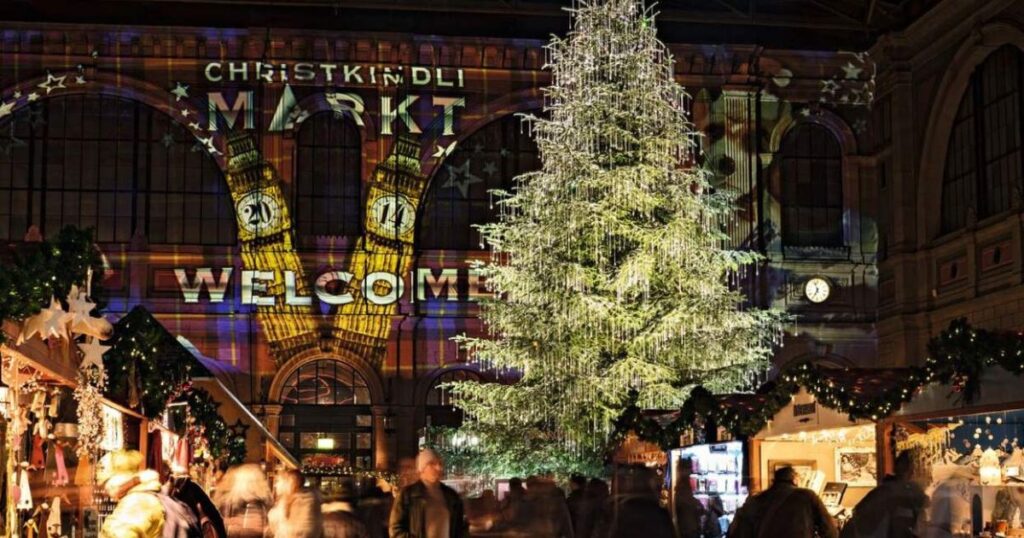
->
left=612, top=319, right=1024, bottom=449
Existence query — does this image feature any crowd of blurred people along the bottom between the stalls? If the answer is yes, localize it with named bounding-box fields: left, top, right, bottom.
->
left=97, top=450, right=928, bottom=538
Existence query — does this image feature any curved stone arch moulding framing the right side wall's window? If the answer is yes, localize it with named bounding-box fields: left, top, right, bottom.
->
left=916, top=23, right=1024, bottom=240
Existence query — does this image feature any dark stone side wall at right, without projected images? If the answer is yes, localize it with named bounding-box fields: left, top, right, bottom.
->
left=870, top=0, right=1024, bottom=365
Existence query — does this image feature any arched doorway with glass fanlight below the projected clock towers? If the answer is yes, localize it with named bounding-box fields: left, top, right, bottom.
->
left=278, top=359, right=374, bottom=469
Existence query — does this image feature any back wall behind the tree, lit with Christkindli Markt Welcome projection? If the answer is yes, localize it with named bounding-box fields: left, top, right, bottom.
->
left=0, top=19, right=880, bottom=468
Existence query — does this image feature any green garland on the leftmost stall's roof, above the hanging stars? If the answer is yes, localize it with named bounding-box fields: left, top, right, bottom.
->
left=0, top=226, right=103, bottom=343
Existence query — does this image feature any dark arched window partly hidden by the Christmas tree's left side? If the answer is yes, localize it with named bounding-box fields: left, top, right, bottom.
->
left=419, top=115, right=541, bottom=250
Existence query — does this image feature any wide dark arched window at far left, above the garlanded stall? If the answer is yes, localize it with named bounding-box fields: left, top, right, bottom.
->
left=0, top=94, right=237, bottom=245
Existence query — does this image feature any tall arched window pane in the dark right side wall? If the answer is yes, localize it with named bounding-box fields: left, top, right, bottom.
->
left=942, top=45, right=1024, bottom=232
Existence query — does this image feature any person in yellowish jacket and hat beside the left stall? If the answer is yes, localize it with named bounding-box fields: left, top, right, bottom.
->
left=96, top=450, right=164, bottom=538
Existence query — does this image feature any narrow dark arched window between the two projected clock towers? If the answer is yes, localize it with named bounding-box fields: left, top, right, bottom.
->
left=292, top=112, right=362, bottom=245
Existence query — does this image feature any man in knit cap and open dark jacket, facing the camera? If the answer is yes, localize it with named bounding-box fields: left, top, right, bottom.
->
left=390, top=449, right=469, bottom=538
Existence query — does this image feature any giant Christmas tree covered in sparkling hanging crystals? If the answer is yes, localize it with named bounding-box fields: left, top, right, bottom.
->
left=452, top=0, right=781, bottom=470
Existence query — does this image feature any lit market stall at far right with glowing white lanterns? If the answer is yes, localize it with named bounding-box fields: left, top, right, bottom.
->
left=882, top=367, right=1024, bottom=536
